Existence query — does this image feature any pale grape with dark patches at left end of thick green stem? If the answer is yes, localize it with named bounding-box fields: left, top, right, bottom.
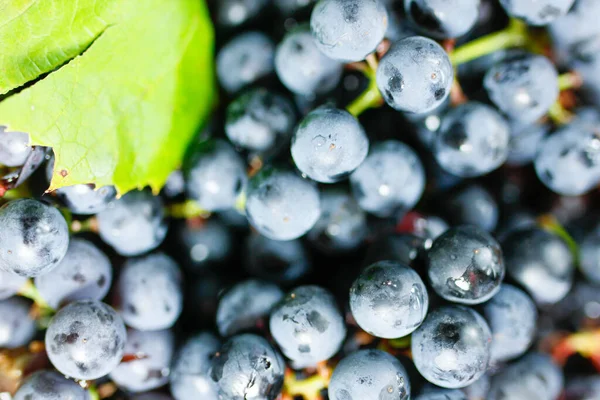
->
left=377, top=36, right=454, bottom=114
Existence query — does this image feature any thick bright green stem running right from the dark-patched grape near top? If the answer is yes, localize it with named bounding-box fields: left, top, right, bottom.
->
left=450, top=19, right=529, bottom=65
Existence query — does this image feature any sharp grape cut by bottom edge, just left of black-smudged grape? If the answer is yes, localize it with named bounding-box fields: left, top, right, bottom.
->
left=328, top=350, right=410, bottom=400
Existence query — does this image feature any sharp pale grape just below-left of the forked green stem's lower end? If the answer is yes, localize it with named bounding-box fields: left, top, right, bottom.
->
left=291, top=107, right=369, bottom=183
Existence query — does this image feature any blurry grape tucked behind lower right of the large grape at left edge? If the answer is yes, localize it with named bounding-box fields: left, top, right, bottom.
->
left=35, top=238, right=112, bottom=308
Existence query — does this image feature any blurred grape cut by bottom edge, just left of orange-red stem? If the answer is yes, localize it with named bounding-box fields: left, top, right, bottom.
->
left=488, top=353, right=563, bottom=400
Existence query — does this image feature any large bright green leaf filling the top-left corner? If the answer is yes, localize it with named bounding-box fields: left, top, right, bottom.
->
left=0, top=0, right=214, bottom=192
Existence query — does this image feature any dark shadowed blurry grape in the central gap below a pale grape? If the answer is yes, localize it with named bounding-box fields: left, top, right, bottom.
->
left=243, top=234, right=312, bottom=284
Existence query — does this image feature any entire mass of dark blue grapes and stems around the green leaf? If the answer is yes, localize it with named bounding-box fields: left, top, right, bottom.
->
left=0, top=0, right=600, bottom=400
